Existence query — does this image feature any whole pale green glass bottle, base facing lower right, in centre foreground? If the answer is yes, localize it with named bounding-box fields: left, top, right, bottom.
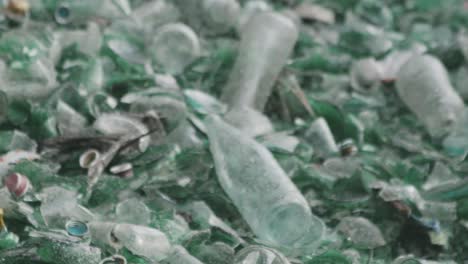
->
left=206, top=116, right=324, bottom=248
